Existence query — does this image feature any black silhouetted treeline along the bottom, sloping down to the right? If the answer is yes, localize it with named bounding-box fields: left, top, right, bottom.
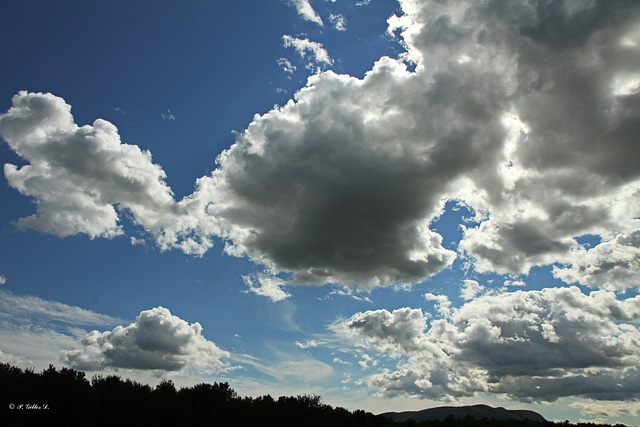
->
left=0, top=363, right=632, bottom=427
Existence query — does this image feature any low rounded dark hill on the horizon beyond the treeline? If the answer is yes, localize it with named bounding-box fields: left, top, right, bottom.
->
left=380, top=405, right=546, bottom=422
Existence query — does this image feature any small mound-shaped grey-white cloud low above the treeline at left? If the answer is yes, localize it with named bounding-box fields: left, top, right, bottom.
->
left=62, top=307, right=230, bottom=372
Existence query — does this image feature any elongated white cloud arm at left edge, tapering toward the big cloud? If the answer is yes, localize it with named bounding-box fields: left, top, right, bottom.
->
left=0, top=91, right=212, bottom=254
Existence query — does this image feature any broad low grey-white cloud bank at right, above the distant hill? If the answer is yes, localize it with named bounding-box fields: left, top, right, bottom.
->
left=332, top=287, right=640, bottom=401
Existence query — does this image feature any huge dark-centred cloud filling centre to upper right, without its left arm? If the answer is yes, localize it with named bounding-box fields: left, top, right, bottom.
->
left=196, top=0, right=640, bottom=287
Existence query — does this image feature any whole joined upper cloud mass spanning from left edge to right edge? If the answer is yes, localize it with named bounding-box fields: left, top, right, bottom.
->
left=0, top=0, right=640, bottom=289
